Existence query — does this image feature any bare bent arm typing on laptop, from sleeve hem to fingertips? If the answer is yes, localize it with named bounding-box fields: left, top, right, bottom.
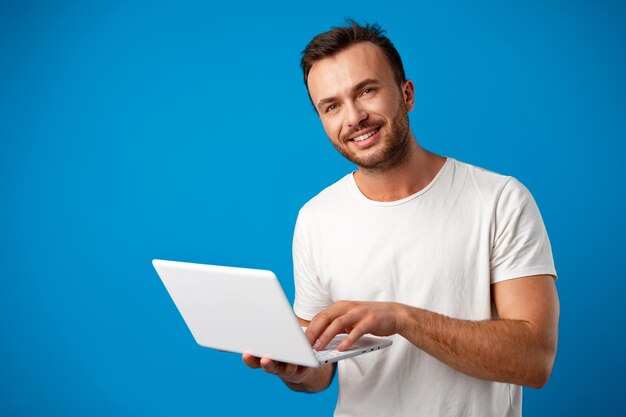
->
left=307, top=275, right=559, bottom=388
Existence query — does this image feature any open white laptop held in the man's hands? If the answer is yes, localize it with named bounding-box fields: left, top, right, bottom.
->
left=152, top=259, right=392, bottom=367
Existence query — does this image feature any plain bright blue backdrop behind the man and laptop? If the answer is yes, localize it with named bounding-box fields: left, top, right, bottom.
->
left=0, top=0, right=626, bottom=416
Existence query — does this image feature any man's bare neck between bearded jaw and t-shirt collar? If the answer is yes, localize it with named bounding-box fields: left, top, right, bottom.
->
left=354, top=134, right=446, bottom=201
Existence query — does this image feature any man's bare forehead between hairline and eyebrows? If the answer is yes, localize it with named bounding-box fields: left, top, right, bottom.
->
left=307, top=42, right=394, bottom=102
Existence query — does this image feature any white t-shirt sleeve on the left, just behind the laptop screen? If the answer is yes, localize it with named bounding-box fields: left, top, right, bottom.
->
left=293, top=211, right=332, bottom=320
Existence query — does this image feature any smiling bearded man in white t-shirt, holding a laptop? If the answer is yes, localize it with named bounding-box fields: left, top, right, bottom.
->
left=243, top=22, right=559, bottom=416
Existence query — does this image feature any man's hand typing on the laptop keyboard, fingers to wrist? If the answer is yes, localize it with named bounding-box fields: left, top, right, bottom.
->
left=306, top=301, right=404, bottom=351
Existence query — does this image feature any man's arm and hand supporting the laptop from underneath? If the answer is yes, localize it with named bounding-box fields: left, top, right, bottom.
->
left=242, top=318, right=336, bottom=392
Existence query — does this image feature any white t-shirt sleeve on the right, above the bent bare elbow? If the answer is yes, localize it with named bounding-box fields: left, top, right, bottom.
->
left=491, top=178, right=556, bottom=284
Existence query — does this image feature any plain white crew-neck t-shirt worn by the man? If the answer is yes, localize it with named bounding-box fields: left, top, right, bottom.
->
left=293, top=158, right=556, bottom=417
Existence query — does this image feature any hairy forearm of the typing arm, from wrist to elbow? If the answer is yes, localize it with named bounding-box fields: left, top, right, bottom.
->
left=399, top=306, right=556, bottom=388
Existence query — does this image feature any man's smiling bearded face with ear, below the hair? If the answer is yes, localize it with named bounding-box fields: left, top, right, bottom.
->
left=308, top=42, right=414, bottom=170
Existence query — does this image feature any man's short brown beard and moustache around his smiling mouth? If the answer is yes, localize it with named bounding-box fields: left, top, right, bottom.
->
left=333, top=102, right=411, bottom=171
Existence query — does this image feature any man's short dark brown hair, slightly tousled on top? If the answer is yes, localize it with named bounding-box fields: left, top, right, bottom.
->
left=300, top=19, right=406, bottom=90
